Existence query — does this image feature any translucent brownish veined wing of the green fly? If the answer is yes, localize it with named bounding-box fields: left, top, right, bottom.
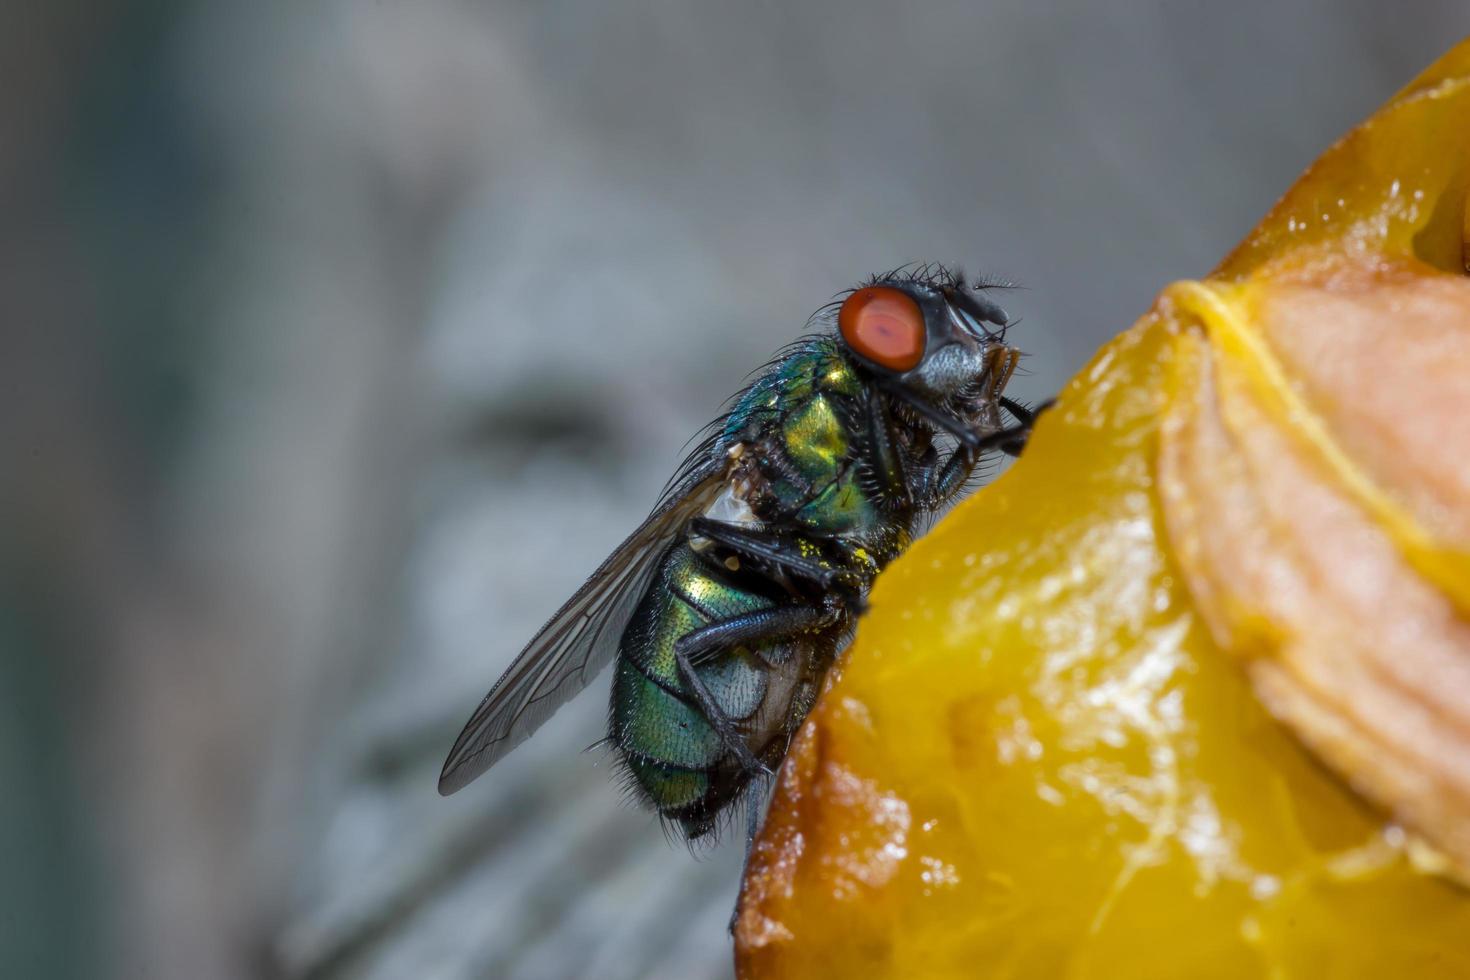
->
left=440, top=447, right=725, bottom=796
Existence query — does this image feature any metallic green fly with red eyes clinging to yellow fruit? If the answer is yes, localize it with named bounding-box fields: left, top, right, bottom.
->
left=440, top=266, right=1035, bottom=840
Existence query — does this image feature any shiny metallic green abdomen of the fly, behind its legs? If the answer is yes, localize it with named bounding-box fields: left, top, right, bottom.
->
left=612, top=541, right=800, bottom=837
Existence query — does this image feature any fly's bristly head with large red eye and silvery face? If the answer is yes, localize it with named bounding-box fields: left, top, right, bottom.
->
left=836, top=267, right=1020, bottom=432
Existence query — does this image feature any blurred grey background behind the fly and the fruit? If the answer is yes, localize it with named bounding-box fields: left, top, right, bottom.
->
left=0, top=0, right=1470, bottom=980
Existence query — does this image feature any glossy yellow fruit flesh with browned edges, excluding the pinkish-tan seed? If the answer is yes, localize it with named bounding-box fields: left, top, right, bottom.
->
left=736, top=36, right=1470, bottom=977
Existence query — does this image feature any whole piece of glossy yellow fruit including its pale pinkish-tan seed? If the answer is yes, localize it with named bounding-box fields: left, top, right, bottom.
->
left=736, top=34, right=1470, bottom=977
